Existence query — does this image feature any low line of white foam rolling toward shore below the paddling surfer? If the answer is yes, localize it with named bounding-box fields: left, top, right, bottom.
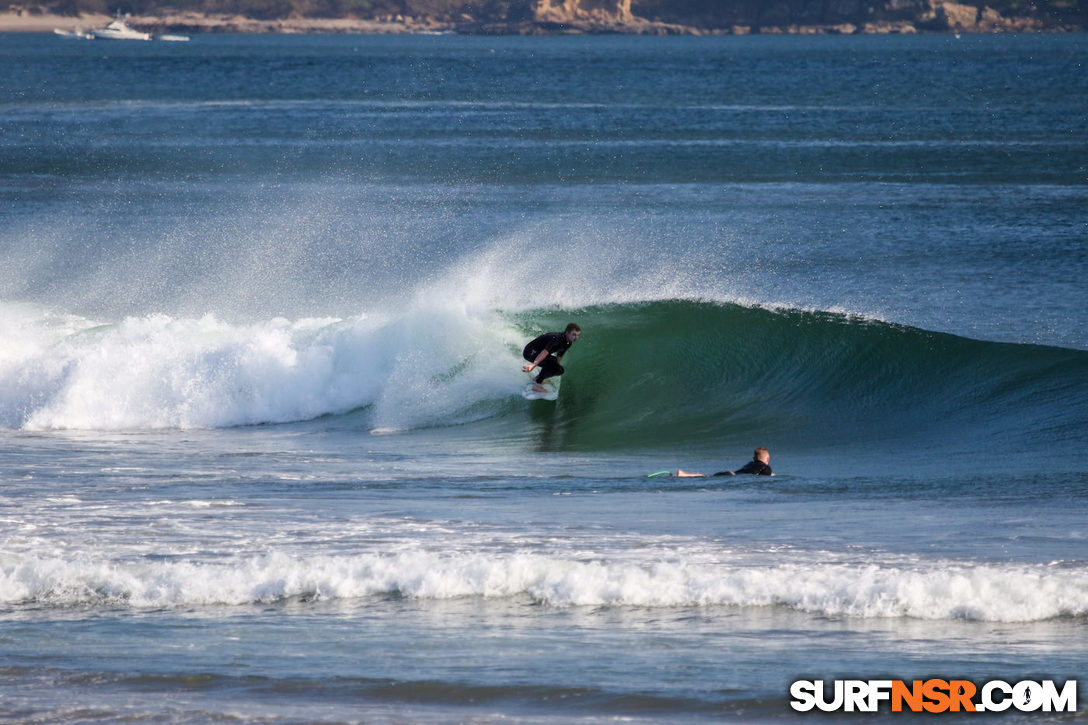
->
left=0, top=551, right=1088, bottom=623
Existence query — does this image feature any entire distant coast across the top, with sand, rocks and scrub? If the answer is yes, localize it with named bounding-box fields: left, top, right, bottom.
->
left=0, top=0, right=1088, bottom=35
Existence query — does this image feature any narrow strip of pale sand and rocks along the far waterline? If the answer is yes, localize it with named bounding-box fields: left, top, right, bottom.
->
left=0, top=12, right=1085, bottom=35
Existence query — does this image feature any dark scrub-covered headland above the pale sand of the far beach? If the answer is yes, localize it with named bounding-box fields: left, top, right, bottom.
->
left=12, top=0, right=1088, bottom=34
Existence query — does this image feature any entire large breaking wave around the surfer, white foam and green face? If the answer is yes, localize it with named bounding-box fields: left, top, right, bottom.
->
left=0, top=299, right=1088, bottom=450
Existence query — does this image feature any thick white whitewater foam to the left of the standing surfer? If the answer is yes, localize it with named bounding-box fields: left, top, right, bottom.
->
left=0, top=305, right=521, bottom=430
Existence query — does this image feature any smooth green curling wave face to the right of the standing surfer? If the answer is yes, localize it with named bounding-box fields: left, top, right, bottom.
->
left=507, top=300, right=1088, bottom=450
